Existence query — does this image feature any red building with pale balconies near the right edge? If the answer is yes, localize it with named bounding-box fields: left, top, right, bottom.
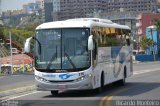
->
left=136, top=13, right=160, bottom=36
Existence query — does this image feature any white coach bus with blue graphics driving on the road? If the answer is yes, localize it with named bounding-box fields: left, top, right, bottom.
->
left=24, top=18, right=133, bottom=95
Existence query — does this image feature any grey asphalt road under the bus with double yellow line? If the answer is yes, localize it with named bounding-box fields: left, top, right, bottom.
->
left=1, top=63, right=160, bottom=106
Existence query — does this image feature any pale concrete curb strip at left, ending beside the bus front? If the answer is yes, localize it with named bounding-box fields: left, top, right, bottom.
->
left=0, top=85, right=36, bottom=98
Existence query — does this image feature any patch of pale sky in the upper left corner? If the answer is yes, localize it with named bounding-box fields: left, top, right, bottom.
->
left=0, top=0, right=35, bottom=11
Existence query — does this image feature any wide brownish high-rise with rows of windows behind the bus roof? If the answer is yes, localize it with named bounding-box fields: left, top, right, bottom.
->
left=59, top=0, right=158, bottom=20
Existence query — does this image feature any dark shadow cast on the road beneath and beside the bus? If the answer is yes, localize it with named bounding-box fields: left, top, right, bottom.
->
left=43, top=82, right=160, bottom=98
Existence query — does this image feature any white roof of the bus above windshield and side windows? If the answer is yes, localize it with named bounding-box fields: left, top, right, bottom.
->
left=36, top=18, right=130, bottom=30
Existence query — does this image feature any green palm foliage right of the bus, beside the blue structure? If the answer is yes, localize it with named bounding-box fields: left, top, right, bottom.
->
left=140, top=37, right=154, bottom=50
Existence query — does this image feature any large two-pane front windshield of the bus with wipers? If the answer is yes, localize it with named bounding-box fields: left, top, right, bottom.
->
left=35, top=28, right=90, bottom=72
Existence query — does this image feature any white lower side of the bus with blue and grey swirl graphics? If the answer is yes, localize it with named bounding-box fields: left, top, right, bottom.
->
left=97, top=46, right=133, bottom=84
